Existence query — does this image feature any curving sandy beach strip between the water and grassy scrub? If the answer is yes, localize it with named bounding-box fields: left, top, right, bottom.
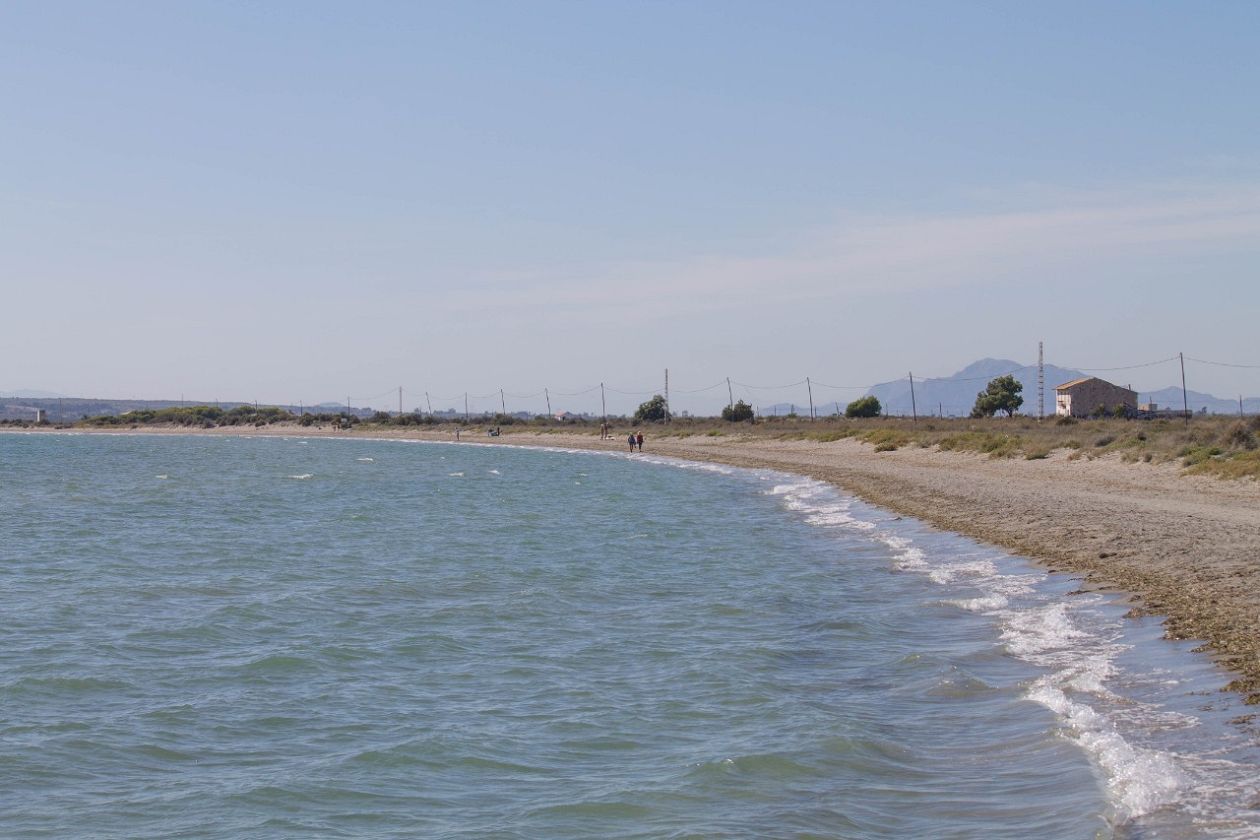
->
left=13, top=426, right=1260, bottom=704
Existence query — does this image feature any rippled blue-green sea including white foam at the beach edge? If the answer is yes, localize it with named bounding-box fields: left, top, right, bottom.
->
left=0, top=434, right=1260, bottom=839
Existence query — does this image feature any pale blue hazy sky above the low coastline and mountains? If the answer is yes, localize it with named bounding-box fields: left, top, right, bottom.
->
left=0, top=0, right=1260, bottom=413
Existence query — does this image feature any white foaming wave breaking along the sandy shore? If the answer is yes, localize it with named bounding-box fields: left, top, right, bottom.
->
left=769, top=476, right=1239, bottom=827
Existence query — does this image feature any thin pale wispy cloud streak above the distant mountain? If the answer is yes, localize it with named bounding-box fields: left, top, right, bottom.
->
left=447, top=185, right=1260, bottom=317
